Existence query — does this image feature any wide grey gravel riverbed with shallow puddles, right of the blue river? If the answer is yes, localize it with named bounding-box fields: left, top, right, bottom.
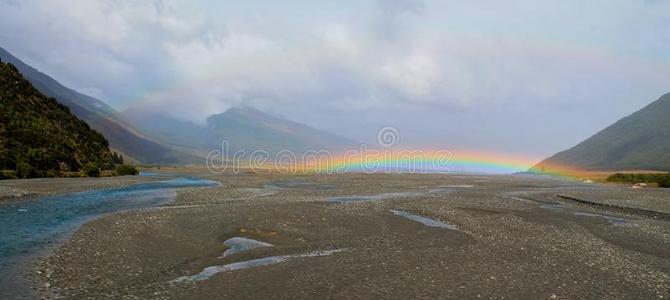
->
left=34, top=170, right=670, bottom=299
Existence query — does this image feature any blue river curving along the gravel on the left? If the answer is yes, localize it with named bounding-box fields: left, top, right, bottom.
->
left=0, top=178, right=219, bottom=294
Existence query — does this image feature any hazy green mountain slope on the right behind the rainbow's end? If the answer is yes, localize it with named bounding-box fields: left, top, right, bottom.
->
left=533, top=93, right=670, bottom=171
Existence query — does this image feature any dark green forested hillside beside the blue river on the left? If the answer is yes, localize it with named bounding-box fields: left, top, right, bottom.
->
left=0, top=62, right=115, bottom=177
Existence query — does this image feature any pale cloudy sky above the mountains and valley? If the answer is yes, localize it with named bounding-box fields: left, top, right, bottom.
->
left=0, top=0, right=670, bottom=161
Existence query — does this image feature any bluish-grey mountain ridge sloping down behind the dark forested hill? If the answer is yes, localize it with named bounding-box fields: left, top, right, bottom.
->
left=0, top=48, right=202, bottom=164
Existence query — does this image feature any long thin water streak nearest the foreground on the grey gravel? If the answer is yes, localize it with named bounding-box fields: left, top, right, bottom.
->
left=173, top=249, right=346, bottom=282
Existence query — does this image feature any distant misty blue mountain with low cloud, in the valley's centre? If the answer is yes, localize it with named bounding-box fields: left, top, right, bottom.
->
left=124, top=107, right=356, bottom=155
